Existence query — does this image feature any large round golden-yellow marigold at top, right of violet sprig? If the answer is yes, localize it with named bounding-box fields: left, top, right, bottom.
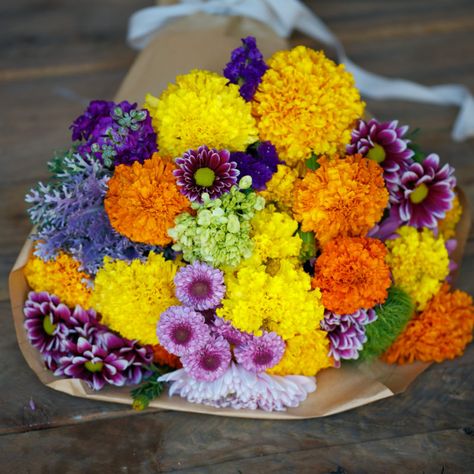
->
left=253, top=46, right=364, bottom=165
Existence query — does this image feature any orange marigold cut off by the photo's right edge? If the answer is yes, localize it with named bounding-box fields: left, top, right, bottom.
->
left=383, top=283, right=474, bottom=364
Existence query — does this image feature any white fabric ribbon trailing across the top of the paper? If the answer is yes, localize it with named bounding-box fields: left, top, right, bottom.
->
left=127, top=0, right=474, bottom=141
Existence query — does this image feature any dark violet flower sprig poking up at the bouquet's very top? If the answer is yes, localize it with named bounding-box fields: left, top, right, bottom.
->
left=224, top=36, right=268, bottom=102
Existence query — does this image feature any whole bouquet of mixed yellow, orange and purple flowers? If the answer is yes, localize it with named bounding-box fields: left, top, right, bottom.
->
left=11, top=37, right=474, bottom=418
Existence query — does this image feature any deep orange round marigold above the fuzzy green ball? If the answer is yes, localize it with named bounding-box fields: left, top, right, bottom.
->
left=312, top=237, right=391, bottom=314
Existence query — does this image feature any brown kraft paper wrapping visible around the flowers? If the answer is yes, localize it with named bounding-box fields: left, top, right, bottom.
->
left=9, top=14, right=470, bottom=420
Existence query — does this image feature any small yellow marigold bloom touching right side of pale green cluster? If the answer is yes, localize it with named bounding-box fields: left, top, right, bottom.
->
left=251, top=205, right=302, bottom=262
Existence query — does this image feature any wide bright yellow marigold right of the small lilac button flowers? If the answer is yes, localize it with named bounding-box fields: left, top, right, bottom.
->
left=217, top=259, right=324, bottom=339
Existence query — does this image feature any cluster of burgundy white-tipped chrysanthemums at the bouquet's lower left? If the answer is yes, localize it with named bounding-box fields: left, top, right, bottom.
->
left=24, top=292, right=153, bottom=390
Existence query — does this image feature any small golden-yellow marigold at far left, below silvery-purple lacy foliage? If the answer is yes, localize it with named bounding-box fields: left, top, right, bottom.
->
left=24, top=252, right=92, bottom=309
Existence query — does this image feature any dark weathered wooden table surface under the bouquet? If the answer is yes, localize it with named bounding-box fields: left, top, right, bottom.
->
left=0, top=0, right=474, bottom=474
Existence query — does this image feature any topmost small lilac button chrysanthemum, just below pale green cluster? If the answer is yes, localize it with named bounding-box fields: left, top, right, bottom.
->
left=174, top=262, right=225, bottom=310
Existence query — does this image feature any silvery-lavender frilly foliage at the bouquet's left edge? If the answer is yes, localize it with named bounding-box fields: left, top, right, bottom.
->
left=25, top=153, right=162, bottom=275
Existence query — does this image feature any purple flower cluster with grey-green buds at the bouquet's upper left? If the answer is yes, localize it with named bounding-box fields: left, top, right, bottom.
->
left=70, top=100, right=157, bottom=166
